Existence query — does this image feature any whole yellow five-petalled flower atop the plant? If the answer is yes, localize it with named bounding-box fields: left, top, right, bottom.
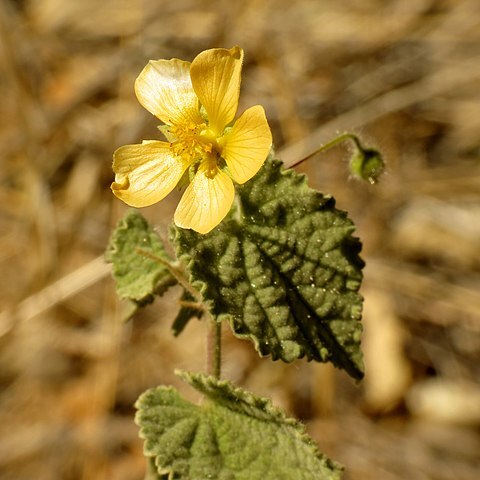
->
left=112, top=47, right=272, bottom=233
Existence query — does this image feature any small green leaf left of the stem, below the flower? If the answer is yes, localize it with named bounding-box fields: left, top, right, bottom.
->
left=105, top=210, right=176, bottom=305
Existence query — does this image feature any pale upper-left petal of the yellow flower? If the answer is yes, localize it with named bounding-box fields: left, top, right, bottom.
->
left=135, top=58, right=202, bottom=125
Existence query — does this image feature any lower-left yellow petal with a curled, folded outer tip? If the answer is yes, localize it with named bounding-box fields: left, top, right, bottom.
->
left=111, top=141, right=188, bottom=207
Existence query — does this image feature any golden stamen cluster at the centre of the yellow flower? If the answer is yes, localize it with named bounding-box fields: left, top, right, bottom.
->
left=169, top=122, right=219, bottom=165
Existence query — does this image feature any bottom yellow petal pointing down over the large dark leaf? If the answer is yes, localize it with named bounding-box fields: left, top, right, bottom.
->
left=174, top=162, right=235, bottom=234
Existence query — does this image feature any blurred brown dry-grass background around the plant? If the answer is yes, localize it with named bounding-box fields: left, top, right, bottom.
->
left=0, top=0, right=480, bottom=480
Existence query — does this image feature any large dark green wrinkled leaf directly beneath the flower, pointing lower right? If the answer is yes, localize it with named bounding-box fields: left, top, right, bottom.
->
left=172, top=160, right=363, bottom=379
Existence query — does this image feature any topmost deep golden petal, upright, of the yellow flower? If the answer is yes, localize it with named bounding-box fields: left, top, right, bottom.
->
left=190, top=47, right=243, bottom=135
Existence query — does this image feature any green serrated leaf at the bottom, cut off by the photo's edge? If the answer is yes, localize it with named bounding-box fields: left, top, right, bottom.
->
left=135, top=373, right=342, bottom=480
